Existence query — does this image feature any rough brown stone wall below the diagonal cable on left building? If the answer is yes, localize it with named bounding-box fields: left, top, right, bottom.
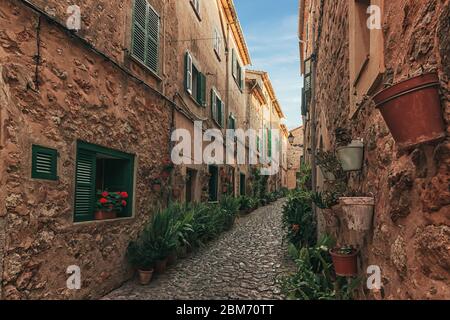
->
left=0, top=0, right=175, bottom=299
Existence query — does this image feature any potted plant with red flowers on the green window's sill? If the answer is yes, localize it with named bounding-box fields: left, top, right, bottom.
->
left=94, top=191, right=128, bottom=220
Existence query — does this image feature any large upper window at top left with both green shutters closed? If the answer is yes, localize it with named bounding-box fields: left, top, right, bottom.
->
left=131, top=0, right=160, bottom=73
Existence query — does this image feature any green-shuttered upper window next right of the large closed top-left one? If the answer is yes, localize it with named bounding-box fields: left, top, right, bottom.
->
left=184, top=52, right=206, bottom=107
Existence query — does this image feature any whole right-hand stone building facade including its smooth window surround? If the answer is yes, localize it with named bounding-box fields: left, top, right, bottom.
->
left=300, top=0, right=450, bottom=299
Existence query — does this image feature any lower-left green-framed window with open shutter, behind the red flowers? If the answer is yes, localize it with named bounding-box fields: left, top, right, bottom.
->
left=74, top=141, right=135, bottom=222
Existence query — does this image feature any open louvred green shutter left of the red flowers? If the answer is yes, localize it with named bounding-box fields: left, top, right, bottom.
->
left=75, top=149, right=96, bottom=222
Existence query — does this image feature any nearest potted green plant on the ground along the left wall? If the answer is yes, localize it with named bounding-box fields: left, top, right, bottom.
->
left=127, top=239, right=155, bottom=285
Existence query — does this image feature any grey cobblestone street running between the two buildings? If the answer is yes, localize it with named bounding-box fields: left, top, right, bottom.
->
left=104, top=200, right=289, bottom=300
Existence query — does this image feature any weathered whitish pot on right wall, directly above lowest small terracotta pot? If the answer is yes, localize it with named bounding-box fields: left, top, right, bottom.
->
left=339, top=197, right=375, bottom=231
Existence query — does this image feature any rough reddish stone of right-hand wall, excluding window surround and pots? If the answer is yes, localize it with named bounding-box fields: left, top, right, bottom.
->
left=316, top=0, right=450, bottom=299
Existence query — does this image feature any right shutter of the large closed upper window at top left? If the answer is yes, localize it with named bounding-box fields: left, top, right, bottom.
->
left=145, top=6, right=159, bottom=72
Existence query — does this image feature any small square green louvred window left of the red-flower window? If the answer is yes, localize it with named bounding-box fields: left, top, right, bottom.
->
left=31, top=145, right=58, bottom=180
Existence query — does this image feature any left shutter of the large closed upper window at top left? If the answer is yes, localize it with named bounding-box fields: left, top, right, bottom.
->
left=132, top=0, right=147, bottom=63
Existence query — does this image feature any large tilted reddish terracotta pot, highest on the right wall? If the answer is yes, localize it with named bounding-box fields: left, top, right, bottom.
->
left=373, top=73, right=445, bottom=148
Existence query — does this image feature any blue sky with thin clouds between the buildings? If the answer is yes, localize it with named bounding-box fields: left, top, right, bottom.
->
left=234, top=0, right=301, bottom=129
